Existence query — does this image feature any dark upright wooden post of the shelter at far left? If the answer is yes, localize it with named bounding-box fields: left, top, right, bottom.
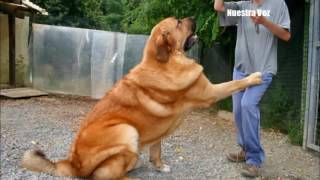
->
left=8, top=14, right=16, bottom=87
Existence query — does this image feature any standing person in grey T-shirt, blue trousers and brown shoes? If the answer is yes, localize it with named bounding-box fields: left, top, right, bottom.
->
left=214, top=0, right=291, bottom=177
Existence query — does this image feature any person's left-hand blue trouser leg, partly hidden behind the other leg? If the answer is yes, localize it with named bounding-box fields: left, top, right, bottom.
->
left=232, top=69, right=246, bottom=148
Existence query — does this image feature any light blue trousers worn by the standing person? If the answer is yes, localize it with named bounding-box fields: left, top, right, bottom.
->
left=232, top=69, right=273, bottom=166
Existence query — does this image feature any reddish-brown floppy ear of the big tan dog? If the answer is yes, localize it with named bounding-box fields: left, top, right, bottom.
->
left=155, top=32, right=171, bottom=62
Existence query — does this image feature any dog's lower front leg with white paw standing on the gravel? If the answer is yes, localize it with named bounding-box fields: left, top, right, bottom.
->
left=149, top=141, right=170, bottom=172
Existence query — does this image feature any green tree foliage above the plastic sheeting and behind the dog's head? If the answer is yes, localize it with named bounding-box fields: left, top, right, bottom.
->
left=34, top=0, right=232, bottom=45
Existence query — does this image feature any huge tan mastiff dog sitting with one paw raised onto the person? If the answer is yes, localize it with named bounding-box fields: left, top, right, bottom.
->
left=22, top=17, right=261, bottom=179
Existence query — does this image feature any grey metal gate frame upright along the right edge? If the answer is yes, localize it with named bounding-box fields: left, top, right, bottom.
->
left=303, top=0, right=320, bottom=152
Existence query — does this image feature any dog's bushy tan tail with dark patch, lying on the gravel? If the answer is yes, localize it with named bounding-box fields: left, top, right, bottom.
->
left=21, top=150, right=77, bottom=176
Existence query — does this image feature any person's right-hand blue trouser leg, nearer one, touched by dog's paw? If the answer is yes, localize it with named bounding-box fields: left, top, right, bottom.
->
left=241, top=74, right=272, bottom=167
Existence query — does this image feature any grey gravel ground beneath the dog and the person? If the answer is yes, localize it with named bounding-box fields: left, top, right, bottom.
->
left=0, top=96, right=320, bottom=180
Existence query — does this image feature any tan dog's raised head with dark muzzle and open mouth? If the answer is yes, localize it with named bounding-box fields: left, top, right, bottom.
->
left=147, top=17, right=198, bottom=62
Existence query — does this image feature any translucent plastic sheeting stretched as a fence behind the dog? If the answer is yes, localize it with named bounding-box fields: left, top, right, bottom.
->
left=30, top=24, right=199, bottom=99
